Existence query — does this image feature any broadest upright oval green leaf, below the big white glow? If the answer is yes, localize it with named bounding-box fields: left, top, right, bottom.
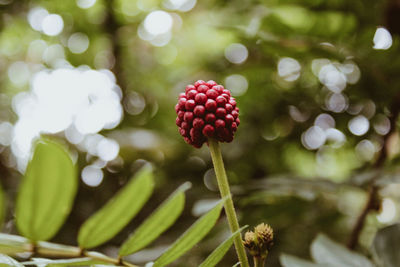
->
left=16, top=140, right=78, bottom=241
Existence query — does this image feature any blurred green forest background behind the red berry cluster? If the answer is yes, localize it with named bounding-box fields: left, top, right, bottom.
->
left=0, top=0, right=400, bottom=266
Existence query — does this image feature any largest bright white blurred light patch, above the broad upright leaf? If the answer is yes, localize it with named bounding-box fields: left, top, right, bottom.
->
left=11, top=67, right=123, bottom=170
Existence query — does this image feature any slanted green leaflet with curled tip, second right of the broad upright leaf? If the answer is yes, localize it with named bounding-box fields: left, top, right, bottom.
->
left=119, top=183, right=190, bottom=256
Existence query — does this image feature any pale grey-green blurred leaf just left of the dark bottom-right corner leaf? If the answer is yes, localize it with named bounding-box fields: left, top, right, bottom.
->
left=311, top=234, right=374, bottom=267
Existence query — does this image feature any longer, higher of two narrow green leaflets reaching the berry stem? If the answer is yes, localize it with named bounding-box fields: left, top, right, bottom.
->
left=153, top=199, right=225, bottom=267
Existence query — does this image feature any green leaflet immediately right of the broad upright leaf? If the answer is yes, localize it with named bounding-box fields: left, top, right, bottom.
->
left=78, top=166, right=154, bottom=248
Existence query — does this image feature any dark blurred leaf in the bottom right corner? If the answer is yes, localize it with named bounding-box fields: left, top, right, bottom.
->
left=372, top=224, right=400, bottom=267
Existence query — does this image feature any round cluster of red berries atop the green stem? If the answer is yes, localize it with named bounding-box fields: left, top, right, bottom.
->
left=175, top=80, right=240, bottom=148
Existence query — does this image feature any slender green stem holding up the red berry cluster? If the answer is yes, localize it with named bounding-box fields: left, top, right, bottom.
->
left=208, top=139, right=249, bottom=267
